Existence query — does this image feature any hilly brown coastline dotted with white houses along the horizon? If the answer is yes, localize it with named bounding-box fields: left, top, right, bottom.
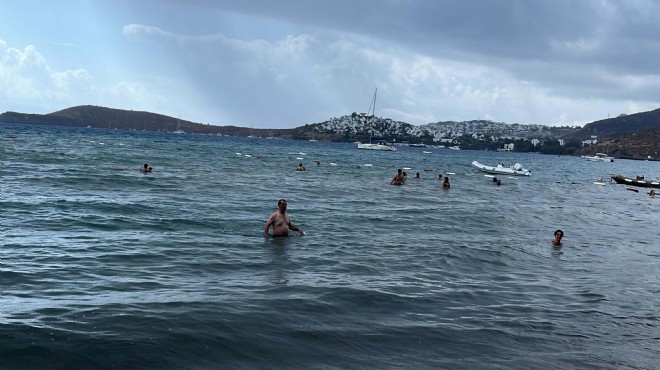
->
left=0, top=105, right=660, bottom=160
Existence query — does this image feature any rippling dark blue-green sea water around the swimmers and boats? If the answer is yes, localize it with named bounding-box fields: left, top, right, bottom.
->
left=0, top=124, right=660, bottom=369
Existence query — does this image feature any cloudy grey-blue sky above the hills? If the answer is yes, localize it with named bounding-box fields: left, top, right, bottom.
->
left=0, top=0, right=660, bottom=128
